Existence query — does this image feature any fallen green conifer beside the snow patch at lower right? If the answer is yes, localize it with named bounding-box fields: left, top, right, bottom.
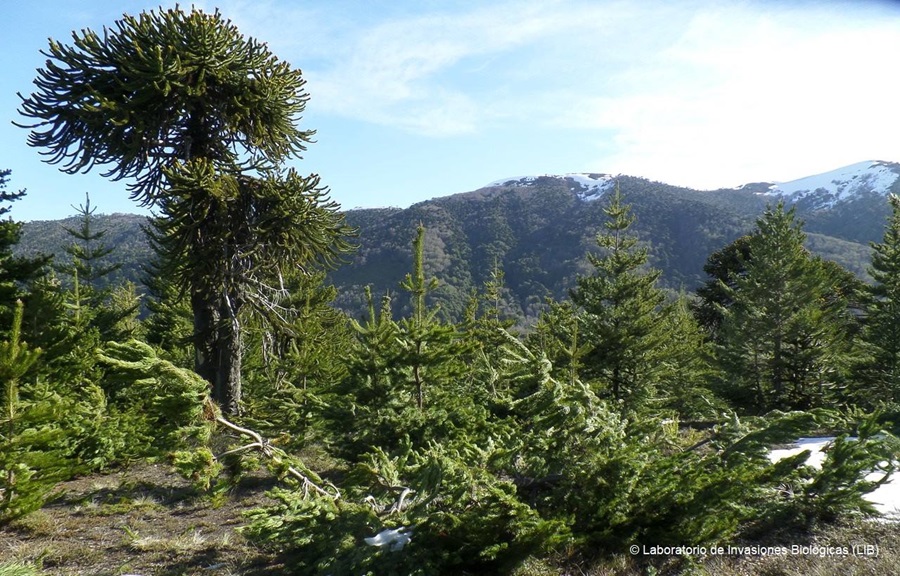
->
left=501, top=332, right=876, bottom=552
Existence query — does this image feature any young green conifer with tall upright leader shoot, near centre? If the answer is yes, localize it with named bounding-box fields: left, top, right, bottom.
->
left=341, top=226, right=474, bottom=453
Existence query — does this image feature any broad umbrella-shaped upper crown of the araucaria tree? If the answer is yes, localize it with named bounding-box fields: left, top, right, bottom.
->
left=20, top=8, right=315, bottom=206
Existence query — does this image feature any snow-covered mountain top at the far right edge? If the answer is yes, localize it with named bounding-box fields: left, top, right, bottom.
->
left=761, top=160, right=900, bottom=209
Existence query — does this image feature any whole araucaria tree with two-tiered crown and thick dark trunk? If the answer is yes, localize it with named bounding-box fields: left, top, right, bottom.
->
left=20, top=8, right=348, bottom=412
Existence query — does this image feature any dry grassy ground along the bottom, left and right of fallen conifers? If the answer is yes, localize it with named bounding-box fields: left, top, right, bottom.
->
left=0, top=464, right=900, bottom=576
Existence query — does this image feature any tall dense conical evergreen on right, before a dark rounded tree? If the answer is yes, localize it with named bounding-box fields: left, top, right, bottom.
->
left=720, top=203, right=852, bottom=411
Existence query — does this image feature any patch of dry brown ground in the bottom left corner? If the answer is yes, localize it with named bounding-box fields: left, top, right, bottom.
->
left=0, top=464, right=283, bottom=576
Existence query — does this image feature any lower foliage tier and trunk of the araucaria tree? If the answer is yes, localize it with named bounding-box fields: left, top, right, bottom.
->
left=151, top=163, right=352, bottom=414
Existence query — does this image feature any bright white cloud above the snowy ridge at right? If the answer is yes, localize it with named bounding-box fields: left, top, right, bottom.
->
left=565, top=6, right=900, bottom=188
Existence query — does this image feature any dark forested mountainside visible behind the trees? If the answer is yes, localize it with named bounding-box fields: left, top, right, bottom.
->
left=16, top=177, right=889, bottom=321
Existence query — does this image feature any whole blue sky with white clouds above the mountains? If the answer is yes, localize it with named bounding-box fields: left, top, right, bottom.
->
left=0, top=0, right=900, bottom=220
